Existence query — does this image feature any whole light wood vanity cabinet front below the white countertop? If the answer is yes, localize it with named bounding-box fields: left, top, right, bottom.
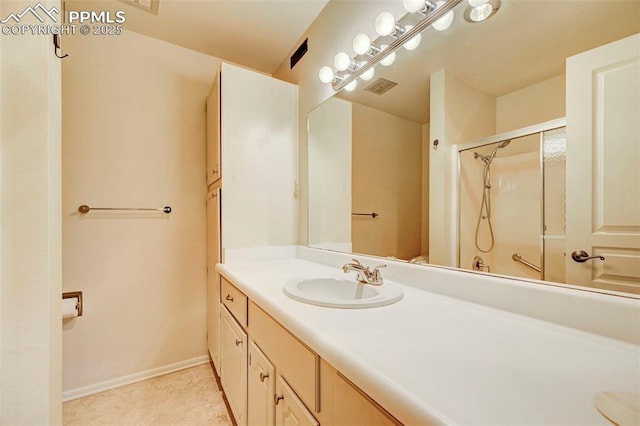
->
left=220, top=276, right=401, bottom=426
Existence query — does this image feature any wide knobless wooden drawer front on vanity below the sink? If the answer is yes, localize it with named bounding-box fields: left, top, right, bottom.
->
left=249, top=302, right=320, bottom=411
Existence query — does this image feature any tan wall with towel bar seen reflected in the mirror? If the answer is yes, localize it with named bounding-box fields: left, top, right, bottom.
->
left=351, top=104, right=422, bottom=259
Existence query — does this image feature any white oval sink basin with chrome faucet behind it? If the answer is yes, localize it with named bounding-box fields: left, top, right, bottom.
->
left=282, top=276, right=403, bottom=309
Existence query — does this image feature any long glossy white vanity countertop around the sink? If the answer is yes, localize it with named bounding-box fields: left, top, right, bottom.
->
left=217, top=259, right=640, bottom=425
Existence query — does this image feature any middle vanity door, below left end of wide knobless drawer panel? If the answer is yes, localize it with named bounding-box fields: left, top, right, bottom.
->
left=247, top=341, right=276, bottom=426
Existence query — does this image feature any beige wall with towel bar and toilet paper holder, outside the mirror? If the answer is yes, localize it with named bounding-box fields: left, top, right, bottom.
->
left=62, top=32, right=219, bottom=397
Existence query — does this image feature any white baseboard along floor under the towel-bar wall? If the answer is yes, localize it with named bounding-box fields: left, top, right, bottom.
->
left=62, top=355, right=209, bottom=402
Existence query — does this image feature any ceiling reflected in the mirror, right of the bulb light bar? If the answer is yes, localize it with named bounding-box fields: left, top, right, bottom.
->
left=332, top=0, right=640, bottom=123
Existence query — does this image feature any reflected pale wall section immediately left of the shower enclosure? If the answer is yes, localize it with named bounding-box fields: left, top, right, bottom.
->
left=429, top=70, right=496, bottom=266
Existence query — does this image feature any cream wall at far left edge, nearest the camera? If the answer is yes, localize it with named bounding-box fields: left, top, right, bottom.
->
left=0, top=1, right=62, bottom=425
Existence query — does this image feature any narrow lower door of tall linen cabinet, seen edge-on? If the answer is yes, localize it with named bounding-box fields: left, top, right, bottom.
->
left=207, top=189, right=220, bottom=372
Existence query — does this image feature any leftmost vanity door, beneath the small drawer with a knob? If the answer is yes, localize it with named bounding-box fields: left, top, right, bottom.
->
left=220, top=307, right=247, bottom=426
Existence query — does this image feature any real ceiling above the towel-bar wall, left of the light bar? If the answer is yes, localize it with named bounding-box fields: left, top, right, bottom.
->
left=65, top=0, right=328, bottom=74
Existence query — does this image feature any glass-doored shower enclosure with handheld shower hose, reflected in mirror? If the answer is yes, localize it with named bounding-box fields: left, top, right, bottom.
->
left=458, top=120, right=566, bottom=282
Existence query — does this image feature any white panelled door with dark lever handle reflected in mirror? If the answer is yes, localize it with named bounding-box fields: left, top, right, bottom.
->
left=566, top=34, right=640, bottom=293
